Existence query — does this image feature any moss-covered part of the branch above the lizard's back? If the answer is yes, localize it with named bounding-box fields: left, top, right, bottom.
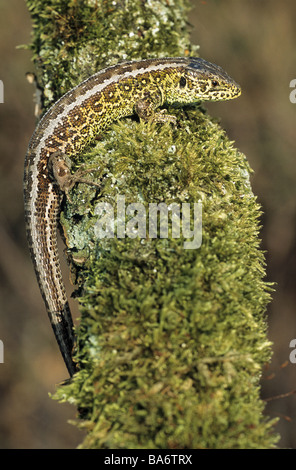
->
left=26, top=0, right=196, bottom=108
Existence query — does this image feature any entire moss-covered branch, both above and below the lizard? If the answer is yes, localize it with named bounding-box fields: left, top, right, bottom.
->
left=27, top=0, right=277, bottom=449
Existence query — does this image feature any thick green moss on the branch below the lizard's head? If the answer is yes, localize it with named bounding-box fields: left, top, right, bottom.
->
left=57, top=109, right=275, bottom=448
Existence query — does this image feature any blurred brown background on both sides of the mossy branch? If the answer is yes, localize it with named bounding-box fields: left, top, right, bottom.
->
left=0, top=0, right=296, bottom=449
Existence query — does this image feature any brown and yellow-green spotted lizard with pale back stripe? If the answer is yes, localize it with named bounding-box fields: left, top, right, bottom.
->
left=24, top=57, right=241, bottom=376
